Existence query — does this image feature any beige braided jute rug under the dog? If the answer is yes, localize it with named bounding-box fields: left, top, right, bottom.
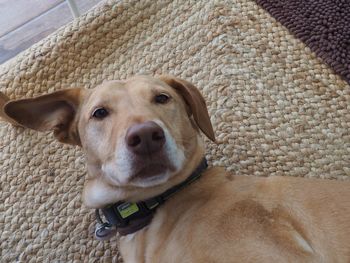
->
left=0, top=0, right=350, bottom=262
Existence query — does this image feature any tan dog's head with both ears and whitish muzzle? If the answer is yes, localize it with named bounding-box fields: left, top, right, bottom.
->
left=4, top=76, right=215, bottom=207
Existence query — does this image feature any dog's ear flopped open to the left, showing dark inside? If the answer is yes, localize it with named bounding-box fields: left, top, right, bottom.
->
left=3, top=88, right=86, bottom=145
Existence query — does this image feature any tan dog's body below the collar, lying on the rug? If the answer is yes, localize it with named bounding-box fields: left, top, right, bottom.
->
left=120, top=168, right=350, bottom=263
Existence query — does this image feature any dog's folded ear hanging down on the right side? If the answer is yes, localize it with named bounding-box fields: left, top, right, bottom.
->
left=158, top=75, right=215, bottom=142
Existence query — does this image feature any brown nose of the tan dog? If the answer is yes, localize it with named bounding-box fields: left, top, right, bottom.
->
left=125, top=121, right=165, bottom=155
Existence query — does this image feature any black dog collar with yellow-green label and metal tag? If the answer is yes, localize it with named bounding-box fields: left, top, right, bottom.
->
left=95, top=158, right=208, bottom=240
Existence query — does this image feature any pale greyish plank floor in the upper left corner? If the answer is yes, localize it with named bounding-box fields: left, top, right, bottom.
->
left=0, top=0, right=101, bottom=64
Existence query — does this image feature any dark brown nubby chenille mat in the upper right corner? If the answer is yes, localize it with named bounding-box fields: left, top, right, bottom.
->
left=256, top=0, right=350, bottom=83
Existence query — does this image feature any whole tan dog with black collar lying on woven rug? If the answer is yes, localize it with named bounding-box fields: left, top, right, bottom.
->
left=1, top=75, right=350, bottom=263
